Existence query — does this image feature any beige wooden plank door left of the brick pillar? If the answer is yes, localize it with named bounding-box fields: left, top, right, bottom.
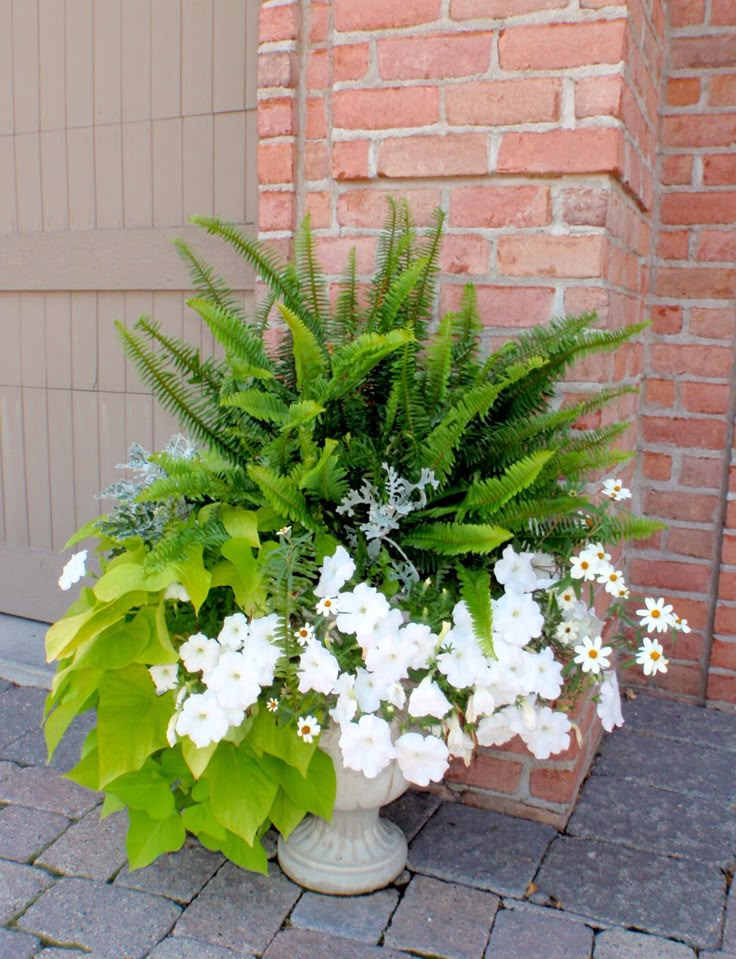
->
left=0, top=0, right=258, bottom=619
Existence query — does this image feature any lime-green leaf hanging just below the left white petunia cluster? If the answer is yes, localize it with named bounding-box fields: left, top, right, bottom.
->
left=207, top=742, right=278, bottom=845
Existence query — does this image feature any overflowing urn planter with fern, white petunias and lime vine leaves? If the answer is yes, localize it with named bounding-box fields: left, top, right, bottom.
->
left=46, top=204, right=687, bottom=892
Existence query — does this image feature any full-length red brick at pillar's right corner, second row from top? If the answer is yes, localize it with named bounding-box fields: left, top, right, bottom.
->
left=498, top=19, right=626, bottom=70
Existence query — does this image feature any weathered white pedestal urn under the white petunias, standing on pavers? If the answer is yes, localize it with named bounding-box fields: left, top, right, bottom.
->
left=278, top=727, right=408, bottom=896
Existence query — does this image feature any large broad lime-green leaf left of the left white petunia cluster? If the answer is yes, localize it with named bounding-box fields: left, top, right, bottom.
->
left=97, top=665, right=174, bottom=786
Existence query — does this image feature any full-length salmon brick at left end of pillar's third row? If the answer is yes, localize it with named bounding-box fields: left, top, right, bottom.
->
left=332, top=87, right=440, bottom=130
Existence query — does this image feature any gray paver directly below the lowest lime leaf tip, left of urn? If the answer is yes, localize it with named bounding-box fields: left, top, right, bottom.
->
left=115, top=839, right=225, bottom=903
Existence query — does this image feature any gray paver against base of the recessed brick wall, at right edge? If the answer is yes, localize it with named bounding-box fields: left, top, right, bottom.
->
left=623, top=695, right=736, bottom=752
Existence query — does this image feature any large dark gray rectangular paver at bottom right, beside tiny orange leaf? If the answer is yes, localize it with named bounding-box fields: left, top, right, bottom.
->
left=532, top=836, right=726, bottom=948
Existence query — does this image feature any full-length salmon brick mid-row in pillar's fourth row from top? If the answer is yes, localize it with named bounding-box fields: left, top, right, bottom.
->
left=378, top=133, right=488, bottom=178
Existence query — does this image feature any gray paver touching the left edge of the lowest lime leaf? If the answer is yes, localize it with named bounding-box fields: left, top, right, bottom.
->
left=37, top=809, right=127, bottom=882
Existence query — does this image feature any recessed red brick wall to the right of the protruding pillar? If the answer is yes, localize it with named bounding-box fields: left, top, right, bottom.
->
left=630, top=0, right=736, bottom=705
